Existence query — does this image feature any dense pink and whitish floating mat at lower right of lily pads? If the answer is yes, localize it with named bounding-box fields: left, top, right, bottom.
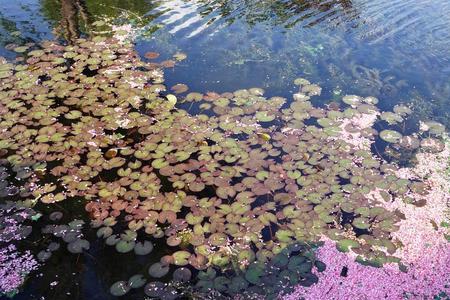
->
left=283, top=141, right=450, bottom=299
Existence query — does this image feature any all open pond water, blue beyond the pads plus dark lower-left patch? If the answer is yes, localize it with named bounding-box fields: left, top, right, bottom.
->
left=0, top=0, right=450, bottom=300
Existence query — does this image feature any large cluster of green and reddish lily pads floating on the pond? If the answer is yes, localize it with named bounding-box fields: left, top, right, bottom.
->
left=0, top=37, right=445, bottom=295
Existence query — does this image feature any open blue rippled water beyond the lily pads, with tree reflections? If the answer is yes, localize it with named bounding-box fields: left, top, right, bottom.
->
left=0, top=0, right=450, bottom=122
